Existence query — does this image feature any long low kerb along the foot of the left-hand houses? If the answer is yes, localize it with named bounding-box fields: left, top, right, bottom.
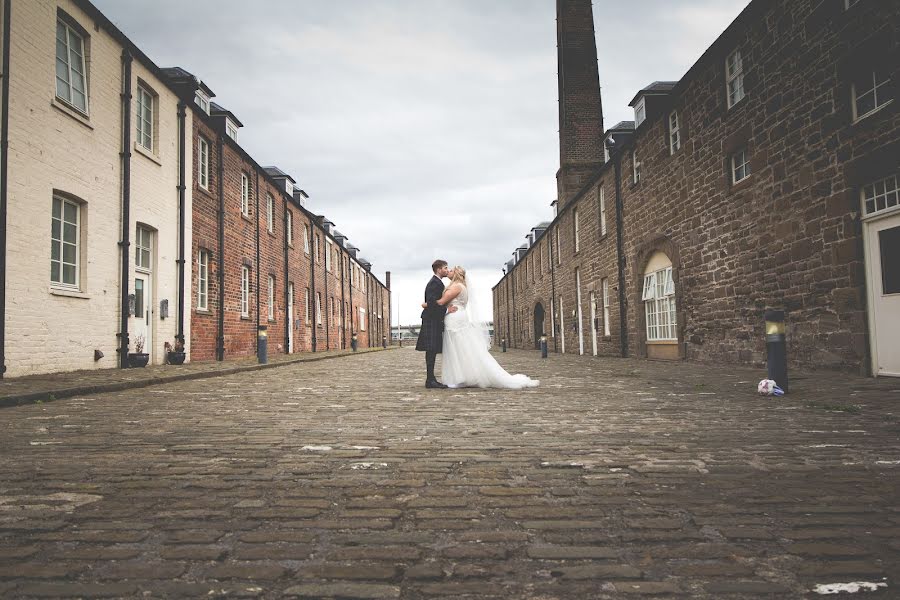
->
left=0, top=346, right=397, bottom=408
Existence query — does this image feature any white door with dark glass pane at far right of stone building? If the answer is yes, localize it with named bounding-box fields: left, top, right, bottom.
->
left=864, top=211, right=900, bottom=377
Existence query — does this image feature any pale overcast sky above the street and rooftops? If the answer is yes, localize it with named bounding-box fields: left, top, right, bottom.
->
left=94, top=0, right=748, bottom=324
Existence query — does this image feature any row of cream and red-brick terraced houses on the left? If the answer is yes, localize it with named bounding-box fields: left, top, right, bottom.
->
left=0, top=0, right=390, bottom=376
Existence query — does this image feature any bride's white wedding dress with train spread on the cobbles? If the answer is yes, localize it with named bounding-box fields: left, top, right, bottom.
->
left=441, top=286, right=540, bottom=390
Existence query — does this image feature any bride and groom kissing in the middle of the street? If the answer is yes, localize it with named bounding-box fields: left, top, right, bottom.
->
left=416, top=260, right=540, bottom=390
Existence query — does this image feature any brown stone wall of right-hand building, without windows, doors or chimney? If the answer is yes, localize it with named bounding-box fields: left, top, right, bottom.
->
left=494, top=0, right=900, bottom=373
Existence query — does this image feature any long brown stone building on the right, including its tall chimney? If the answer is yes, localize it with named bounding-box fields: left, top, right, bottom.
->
left=494, top=0, right=900, bottom=375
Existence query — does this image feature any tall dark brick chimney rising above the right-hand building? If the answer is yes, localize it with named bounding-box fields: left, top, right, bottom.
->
left=556, top=0, right=603, bottom=209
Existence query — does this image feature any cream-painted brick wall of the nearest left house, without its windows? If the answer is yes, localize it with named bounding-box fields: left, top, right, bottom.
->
left=6, top=0, right=191, bottom=376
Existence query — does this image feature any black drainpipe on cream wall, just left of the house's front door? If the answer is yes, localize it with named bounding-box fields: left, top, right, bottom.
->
left=117, top=51, right=134, bottom=369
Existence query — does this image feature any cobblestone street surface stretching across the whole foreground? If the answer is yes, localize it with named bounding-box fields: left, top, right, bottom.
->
left=0, top=349, right=900, bottom=600
